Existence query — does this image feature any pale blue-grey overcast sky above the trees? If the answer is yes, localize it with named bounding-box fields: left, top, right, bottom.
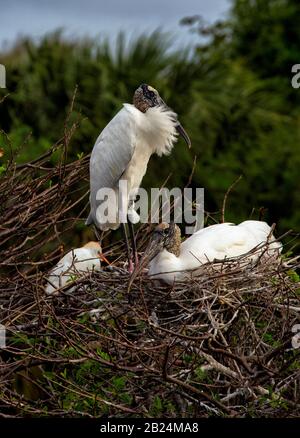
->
left=0, top=0, right=230, bottom=46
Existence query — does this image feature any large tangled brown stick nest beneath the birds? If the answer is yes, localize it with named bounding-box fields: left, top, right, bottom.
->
left=0, top=133, right=300, bottom=417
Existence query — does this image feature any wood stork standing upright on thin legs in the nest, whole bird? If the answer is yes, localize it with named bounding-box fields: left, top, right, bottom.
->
left=86, top=84, right=191, bottom=270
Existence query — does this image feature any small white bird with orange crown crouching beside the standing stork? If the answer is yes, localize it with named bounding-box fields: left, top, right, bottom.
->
left=45, top=242, right=101, bottom=295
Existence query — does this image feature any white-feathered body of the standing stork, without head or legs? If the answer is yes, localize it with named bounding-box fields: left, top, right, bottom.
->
left=87, top=103, right=178, bottom=230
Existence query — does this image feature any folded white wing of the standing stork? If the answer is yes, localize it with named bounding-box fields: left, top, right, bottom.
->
left=86, top=105, right=136, bottom=226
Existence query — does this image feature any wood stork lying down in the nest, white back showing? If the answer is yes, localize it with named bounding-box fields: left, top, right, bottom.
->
left=137, top=220, right=282, bottom=284
